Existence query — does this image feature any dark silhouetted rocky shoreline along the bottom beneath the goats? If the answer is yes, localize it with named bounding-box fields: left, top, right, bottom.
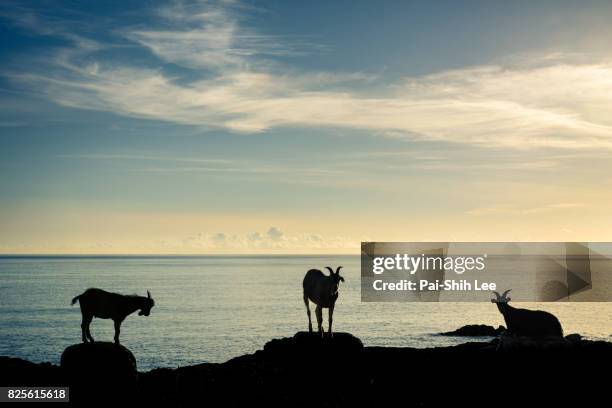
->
left=0, top=333, right=612, bottom=408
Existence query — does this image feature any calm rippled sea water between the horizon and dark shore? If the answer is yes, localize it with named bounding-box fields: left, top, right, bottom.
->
left=0, top=256, right=612, bottom=370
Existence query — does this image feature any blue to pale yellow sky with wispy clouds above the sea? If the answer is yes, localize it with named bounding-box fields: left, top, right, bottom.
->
left=0, top=0, right=612, bottom=254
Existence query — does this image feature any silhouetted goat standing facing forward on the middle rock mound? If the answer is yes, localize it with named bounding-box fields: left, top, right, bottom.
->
left=302, top=266, right=344, bottom=337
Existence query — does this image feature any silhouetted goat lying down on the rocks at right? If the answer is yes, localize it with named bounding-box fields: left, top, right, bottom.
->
left=491, top=289, right=563, bottom=337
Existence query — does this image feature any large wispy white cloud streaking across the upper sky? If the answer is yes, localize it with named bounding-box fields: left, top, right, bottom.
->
left=6, top=2, right=612, bottom=149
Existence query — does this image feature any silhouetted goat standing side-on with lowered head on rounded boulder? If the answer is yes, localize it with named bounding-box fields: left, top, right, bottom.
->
left=71, top=288, right=155, bottom=344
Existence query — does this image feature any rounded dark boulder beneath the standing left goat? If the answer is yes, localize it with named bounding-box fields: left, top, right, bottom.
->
left=61, top=342, right=138, bottom=403
